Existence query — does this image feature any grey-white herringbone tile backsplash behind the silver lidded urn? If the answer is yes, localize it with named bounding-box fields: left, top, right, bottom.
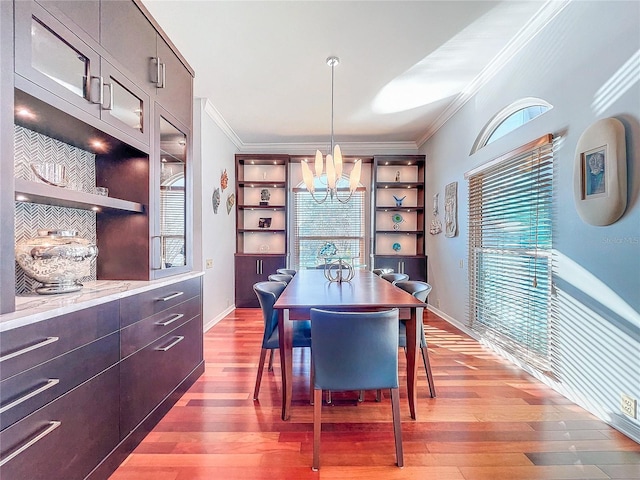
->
left=14, top=125, right=96, bottom=295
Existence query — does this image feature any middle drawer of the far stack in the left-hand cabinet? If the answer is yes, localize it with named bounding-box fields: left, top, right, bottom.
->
left=120, top=296, right=202, bottom=358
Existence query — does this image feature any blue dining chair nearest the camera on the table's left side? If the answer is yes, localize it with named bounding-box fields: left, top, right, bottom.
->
left=253, top=281, right=313, bottom=400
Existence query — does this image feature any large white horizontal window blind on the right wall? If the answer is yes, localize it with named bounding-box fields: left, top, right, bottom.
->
left=466, top=135, right=553, bottom=371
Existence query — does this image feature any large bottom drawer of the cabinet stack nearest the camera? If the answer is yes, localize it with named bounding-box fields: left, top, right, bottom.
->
left=0, top=365, right=119, bottom=480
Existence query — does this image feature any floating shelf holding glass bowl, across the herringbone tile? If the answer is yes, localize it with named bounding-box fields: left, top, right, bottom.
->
left=15, top=178, right=145, bottom=213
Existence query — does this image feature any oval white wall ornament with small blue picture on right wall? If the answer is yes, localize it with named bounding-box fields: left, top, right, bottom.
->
left=573, top=118, right=627, bottom=226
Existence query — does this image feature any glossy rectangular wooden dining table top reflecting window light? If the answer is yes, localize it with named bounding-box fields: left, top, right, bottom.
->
left=274, top=269, right=424, bottom=310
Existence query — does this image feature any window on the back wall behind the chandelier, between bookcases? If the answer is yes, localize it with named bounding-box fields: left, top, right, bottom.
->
left=292, top=176, right=366, bottom=269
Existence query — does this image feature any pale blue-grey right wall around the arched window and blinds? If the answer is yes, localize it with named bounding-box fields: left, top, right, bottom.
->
left=421, top=1, right=640, bottom=440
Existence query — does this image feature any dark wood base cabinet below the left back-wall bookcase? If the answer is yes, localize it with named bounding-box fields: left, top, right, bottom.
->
left=235, top=254, right=287, bottom=308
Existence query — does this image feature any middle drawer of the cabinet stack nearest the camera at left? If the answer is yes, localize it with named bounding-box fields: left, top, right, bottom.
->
left=0, top=332, right=120, bottom=430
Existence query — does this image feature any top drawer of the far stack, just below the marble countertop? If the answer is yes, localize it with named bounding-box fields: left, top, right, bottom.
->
left=120, top=277, right=201, bottom=328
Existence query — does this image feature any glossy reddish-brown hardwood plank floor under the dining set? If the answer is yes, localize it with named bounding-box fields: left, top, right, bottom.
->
left=111, top=309, right=640, bottom=480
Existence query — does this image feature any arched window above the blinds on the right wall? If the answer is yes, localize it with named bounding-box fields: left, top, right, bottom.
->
left=471, top=97, right=553, bottom=154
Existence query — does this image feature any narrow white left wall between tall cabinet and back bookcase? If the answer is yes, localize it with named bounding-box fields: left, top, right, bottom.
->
left=193, top=99, right=237, bottom=330
